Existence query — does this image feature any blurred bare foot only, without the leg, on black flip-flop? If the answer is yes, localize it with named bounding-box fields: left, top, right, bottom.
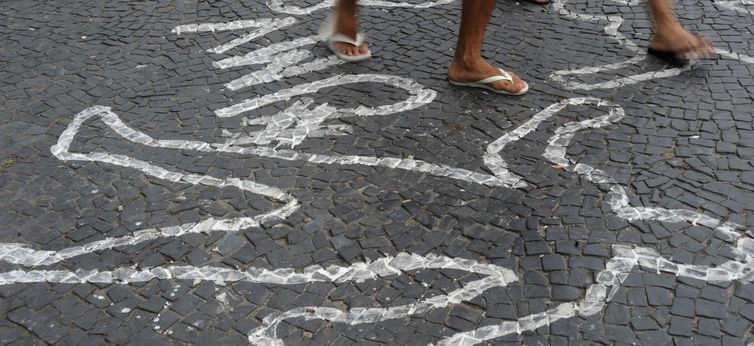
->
left=649, top=22, right=715, bottom=59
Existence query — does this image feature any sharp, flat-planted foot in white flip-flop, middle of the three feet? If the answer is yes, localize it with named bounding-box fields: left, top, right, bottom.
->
left=448, top=58, right=528, bottom=94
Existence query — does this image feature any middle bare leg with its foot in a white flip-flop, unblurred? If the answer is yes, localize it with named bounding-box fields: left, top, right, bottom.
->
left=448, top=0, right=528, bottom=94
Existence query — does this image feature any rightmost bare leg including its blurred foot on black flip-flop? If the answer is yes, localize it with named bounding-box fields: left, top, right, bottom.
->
left=647, top=0, right=715, bottom=58
